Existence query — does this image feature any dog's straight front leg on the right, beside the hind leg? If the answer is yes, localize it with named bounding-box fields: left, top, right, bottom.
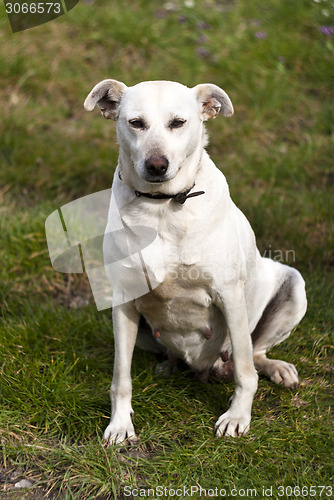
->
left=215, top=281, right=258, bottom=436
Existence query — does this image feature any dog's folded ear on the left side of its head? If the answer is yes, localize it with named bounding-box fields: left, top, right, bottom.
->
left=84, top=79, right=127, bottom=120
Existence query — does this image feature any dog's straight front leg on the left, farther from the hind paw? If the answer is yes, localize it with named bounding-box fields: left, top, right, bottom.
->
left=103, top=303, right=140, bottom=444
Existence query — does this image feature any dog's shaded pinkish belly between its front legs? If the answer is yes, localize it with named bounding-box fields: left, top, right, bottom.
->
left=136, top=279, right=231, bottom=371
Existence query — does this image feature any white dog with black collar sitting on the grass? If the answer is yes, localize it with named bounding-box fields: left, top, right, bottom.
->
left=85, top=80, right=306, bottom=444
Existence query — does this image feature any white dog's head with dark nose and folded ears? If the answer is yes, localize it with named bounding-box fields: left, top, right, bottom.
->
left=84, top=80, right=233, bottom=191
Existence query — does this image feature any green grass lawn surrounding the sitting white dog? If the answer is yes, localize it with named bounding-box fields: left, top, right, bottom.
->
left=0, top=0, right=334, bottom=500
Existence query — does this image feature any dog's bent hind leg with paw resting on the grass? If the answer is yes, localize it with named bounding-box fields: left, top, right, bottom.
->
left=252, top=267, right=307, bottom=388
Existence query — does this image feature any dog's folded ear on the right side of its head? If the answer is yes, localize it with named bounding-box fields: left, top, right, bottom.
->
left=193, top=83, right=234, bottom=121
